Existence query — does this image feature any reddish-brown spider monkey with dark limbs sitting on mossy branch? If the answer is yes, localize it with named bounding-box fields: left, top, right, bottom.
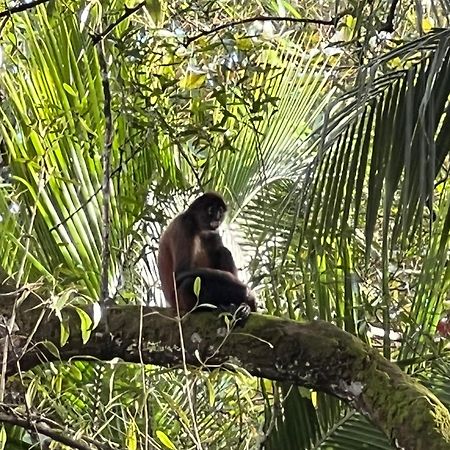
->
left=158, top=192, right=256, bottom=311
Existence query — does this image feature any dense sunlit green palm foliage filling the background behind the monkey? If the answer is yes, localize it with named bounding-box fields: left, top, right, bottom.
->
left=0, top=0, right=450, bottom=450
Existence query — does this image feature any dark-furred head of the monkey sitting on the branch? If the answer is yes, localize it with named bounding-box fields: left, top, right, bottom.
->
left=189, top=192, right=227, bottom=231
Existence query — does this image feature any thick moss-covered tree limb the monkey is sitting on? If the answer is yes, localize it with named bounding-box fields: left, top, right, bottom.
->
left=0, top=274, right=450, bottom=450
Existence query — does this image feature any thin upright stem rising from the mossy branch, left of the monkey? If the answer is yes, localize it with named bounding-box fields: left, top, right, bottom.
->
left=97, top=42, right=113, bottom=305
